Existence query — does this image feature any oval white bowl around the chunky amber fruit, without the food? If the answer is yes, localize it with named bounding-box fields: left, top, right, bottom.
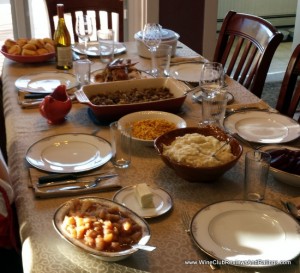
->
left=53, top=197, right=150, bottom=262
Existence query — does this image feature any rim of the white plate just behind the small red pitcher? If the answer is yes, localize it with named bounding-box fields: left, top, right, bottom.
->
left=15, top=70, right=79, bottom=93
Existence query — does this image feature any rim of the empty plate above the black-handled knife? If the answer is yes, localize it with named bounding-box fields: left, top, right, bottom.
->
left=25, top=133, right=112, bottom=173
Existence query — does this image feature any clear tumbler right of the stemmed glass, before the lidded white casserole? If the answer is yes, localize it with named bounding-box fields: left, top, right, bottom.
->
left=151, top=44, right=172, bottom=77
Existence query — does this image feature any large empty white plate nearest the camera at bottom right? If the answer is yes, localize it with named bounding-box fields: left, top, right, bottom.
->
left=190, top=200, right=300, bottom=267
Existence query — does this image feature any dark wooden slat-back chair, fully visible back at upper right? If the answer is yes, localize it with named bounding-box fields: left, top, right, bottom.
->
left=213, top=11, right=283, bottom=97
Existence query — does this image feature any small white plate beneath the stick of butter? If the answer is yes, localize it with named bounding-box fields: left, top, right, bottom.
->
left=113, top=186, right=173, bottom=218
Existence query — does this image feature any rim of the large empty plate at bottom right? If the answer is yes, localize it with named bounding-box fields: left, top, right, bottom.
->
left=190, top=199, right=300, bottom=268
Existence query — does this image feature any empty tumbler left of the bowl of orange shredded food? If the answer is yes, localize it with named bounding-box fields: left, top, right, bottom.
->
left=110, top=121, right=131, bottom=169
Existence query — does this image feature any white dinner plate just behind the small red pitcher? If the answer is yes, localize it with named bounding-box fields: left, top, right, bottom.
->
left=15, top=71, right=79, bottom=93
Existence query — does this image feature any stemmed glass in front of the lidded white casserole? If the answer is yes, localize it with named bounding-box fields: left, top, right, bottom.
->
left=143, top=23, right=162, bottom=74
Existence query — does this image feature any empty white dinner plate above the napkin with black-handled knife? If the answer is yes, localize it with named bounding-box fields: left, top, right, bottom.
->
left=26, top=134, right=112, bottom=173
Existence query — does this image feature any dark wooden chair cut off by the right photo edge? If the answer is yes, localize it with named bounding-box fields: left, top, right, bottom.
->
left=276, top=44, right=300, bottom=123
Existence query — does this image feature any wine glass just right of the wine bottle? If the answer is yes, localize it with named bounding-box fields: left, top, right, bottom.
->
left=76, top=15, right=93, bottom=54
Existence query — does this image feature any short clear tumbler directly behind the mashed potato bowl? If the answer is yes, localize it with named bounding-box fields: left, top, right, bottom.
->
left=199, top=89, right=227, bottom=128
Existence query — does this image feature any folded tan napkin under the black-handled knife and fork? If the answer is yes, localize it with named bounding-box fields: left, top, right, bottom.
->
left=28, top=164, right=122, bottom=198
